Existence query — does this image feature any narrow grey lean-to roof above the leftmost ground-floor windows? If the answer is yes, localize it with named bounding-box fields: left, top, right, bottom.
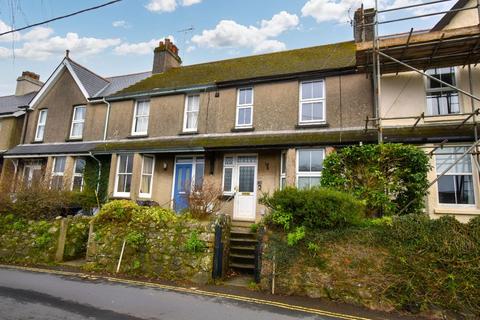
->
left=5, top=142, right=98, bottom=156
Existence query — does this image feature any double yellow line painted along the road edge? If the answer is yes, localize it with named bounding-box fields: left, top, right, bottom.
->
left=0, top=264, right=373, bottom=320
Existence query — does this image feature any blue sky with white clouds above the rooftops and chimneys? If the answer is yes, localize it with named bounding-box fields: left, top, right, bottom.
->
left=0, top=0, right=455, bottom=96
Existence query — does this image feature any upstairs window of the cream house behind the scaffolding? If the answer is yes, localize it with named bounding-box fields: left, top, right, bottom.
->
left=427, top=67, right=460, bottom=115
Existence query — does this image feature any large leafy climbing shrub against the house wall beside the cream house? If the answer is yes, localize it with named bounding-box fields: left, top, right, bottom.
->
left=321, top=143, right=430, bottom=217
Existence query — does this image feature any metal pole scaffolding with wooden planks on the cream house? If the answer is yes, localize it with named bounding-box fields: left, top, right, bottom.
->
left=355, top=0, right=480, bottom=212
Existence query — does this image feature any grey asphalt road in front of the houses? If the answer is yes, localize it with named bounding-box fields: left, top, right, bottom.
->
left=0, top=268, right=378, bottom=320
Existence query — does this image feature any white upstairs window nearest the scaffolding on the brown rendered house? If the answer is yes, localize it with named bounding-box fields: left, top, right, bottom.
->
left=300, top=80, right=325, bottom=124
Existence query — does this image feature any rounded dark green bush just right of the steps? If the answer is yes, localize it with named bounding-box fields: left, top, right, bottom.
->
left=261, top=187, right=363, bottom=230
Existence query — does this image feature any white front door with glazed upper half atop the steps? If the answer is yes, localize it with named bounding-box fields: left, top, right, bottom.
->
left=233, top=155, right=257, bottom=221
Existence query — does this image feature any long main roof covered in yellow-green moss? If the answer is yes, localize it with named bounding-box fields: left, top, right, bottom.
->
left=116, top=41, right=355, bottom=95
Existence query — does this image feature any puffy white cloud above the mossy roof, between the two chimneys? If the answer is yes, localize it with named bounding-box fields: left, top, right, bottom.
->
left=191, top=11, right=299, bottom=53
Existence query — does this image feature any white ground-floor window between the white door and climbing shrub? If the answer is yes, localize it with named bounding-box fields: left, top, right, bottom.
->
left=297, top=149, right=325, bottom=189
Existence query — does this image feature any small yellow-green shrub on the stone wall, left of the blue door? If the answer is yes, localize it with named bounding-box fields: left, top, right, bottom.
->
left=94, top=200, right=140, bottom=223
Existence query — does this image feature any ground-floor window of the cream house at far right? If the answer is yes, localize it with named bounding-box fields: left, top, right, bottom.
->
left=435, top=147, right=475, bottom=205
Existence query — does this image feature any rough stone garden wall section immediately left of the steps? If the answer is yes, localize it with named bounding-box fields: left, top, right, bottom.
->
left=87, top=216, right=229, bottom=284
